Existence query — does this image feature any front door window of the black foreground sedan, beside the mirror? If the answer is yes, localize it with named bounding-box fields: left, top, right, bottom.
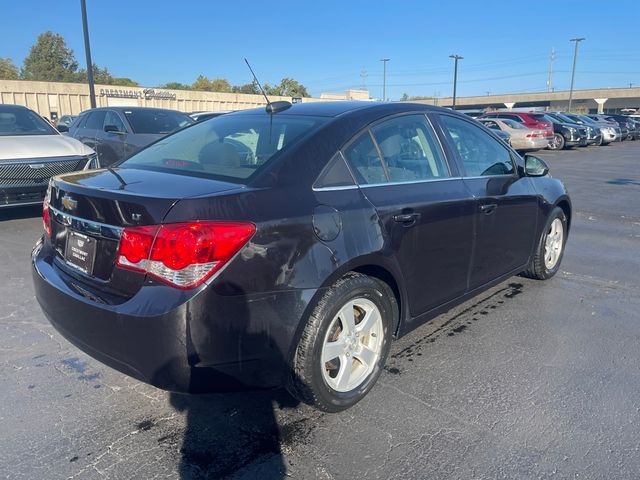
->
left=440, top=115, right=515, bottom=177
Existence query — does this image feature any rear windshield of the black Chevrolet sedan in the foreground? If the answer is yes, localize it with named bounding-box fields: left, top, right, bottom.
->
left=120, top=114, right=325, bottom=183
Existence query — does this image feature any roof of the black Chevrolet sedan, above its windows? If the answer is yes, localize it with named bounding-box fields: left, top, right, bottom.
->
left=229, top=101, right=442, bottom=117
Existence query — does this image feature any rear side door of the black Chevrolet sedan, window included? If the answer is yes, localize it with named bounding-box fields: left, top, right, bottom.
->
left=343, top=114, right=474, bottom=317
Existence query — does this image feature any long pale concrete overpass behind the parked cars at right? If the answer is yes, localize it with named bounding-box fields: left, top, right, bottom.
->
left=418, top=87, right=640, bottom=113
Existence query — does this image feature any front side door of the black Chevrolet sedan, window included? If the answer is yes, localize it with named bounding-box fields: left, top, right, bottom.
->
left=438, top=114, right=538, bottom=290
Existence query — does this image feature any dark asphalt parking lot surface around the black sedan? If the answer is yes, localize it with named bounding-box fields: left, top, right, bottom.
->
left=0, top=142, right=640, bottom=479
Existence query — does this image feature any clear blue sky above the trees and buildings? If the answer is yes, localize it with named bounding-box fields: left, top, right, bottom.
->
left=0, top=0, right=640, bottom=99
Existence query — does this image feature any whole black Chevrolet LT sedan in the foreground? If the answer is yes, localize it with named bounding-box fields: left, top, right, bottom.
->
left=32, top=102, right=571, bottom=411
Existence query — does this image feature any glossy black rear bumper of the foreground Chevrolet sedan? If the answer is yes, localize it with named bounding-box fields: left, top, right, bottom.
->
left=32, top=241, right=317, bottom=393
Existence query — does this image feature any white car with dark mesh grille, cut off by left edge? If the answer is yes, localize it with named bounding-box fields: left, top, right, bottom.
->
left=0, top=104, right=95, bottom=208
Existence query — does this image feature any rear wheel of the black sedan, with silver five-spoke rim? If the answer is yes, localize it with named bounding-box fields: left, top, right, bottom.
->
left=287, top=273, right=397, bottom=412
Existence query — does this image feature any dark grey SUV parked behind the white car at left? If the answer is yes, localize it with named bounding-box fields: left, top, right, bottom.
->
left=67, top=107, right=194, bottom=167
